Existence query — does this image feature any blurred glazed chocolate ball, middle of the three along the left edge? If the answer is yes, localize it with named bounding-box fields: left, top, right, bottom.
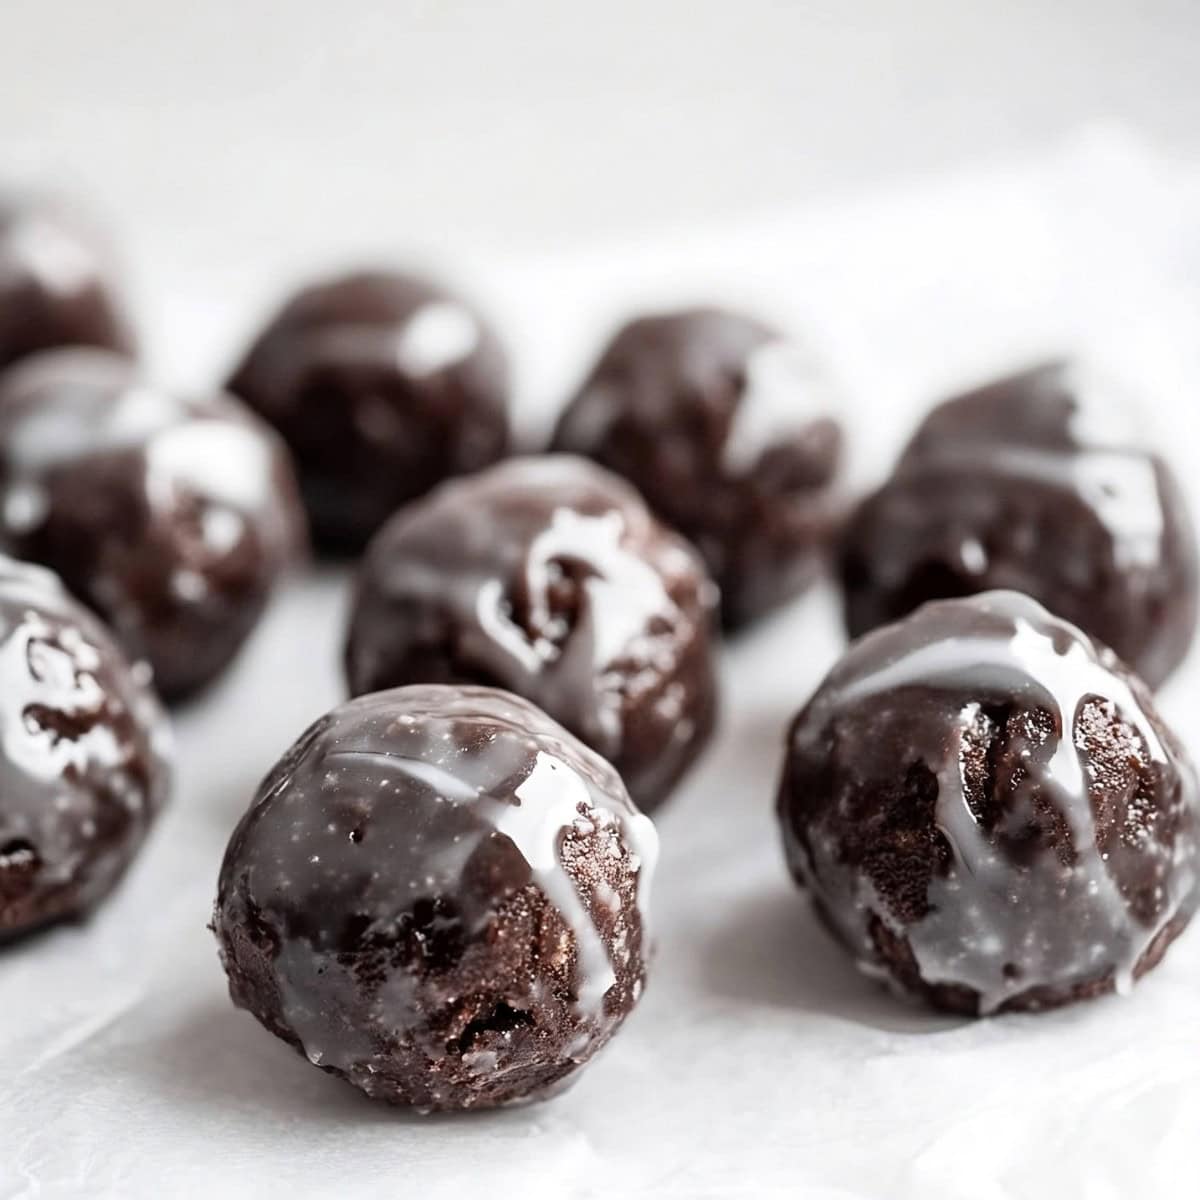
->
left=0, top=349, right=302, bottom=698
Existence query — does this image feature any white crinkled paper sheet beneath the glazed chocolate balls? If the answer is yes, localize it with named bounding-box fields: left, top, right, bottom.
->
left=0, top=136, right=1200, bottom=1200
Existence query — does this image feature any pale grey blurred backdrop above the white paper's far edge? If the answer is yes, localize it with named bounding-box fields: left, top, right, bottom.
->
left=0, top=0, right=1200, bottom=253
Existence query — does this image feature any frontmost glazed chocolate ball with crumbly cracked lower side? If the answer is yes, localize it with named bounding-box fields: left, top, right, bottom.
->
left=214, top=686, right=658, bottom=1111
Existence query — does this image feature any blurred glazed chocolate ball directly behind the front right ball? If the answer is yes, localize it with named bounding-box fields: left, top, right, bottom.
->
left=841, top=362, right=1196, bottom=686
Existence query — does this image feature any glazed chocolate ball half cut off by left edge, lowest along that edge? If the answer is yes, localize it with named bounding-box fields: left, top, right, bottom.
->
left=0, top=557, right=170, bottom=941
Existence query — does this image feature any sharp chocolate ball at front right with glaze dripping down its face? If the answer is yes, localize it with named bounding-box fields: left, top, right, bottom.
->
left=779, top=592, right=1200, bottom=1015
